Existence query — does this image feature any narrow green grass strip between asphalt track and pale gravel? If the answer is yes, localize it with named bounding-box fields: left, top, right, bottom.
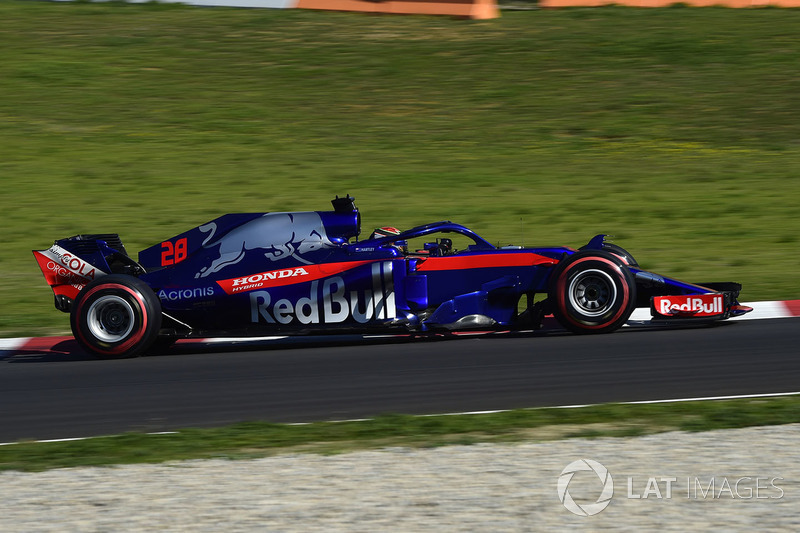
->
left=0, top=396, right=800, bottom=471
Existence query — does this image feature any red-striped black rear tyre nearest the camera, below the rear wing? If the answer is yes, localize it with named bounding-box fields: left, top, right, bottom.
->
left=70, top=274, right=161, bottom=359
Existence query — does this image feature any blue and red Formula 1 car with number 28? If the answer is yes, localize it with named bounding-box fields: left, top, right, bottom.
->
left=33, top=195, right=750, bottom=357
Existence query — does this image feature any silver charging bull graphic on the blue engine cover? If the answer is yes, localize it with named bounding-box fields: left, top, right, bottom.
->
left=195, top=211, right=334, bottom=278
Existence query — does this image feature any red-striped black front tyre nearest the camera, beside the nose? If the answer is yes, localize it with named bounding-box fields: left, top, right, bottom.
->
left=549, top=250, right=636, bottom=333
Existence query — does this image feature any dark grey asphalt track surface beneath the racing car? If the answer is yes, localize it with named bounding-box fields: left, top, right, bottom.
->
left=0, top=318, right=800, bottom=442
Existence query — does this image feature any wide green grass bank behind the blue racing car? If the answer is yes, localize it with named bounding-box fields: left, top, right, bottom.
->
left=0, top=4, right=800, bottom=336
